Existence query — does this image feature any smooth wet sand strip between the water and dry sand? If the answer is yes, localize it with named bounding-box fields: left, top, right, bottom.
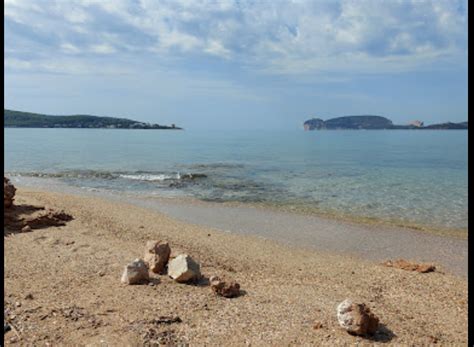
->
left=5, top=184, right=468, bottom=278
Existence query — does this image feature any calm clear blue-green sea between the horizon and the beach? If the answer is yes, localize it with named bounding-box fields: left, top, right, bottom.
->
left=4, top=128, right=468, bottom=229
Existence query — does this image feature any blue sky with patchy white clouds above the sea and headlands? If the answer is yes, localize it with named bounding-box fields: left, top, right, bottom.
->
left=4, top=0, right=467, bottom=129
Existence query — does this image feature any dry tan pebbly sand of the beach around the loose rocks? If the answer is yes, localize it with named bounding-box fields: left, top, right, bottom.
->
left=4, top=189, right=467, bottom=346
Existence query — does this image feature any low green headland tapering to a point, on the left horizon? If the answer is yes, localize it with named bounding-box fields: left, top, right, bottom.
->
left=3, top=109, right=182, bottom=130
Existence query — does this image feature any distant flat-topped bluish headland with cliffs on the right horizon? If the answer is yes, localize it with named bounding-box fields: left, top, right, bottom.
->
left=303, top=115, right=468, bottom=130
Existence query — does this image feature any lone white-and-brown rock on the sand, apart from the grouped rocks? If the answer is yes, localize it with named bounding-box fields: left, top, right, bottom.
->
left=337, top=299, right=379, bottom=335
